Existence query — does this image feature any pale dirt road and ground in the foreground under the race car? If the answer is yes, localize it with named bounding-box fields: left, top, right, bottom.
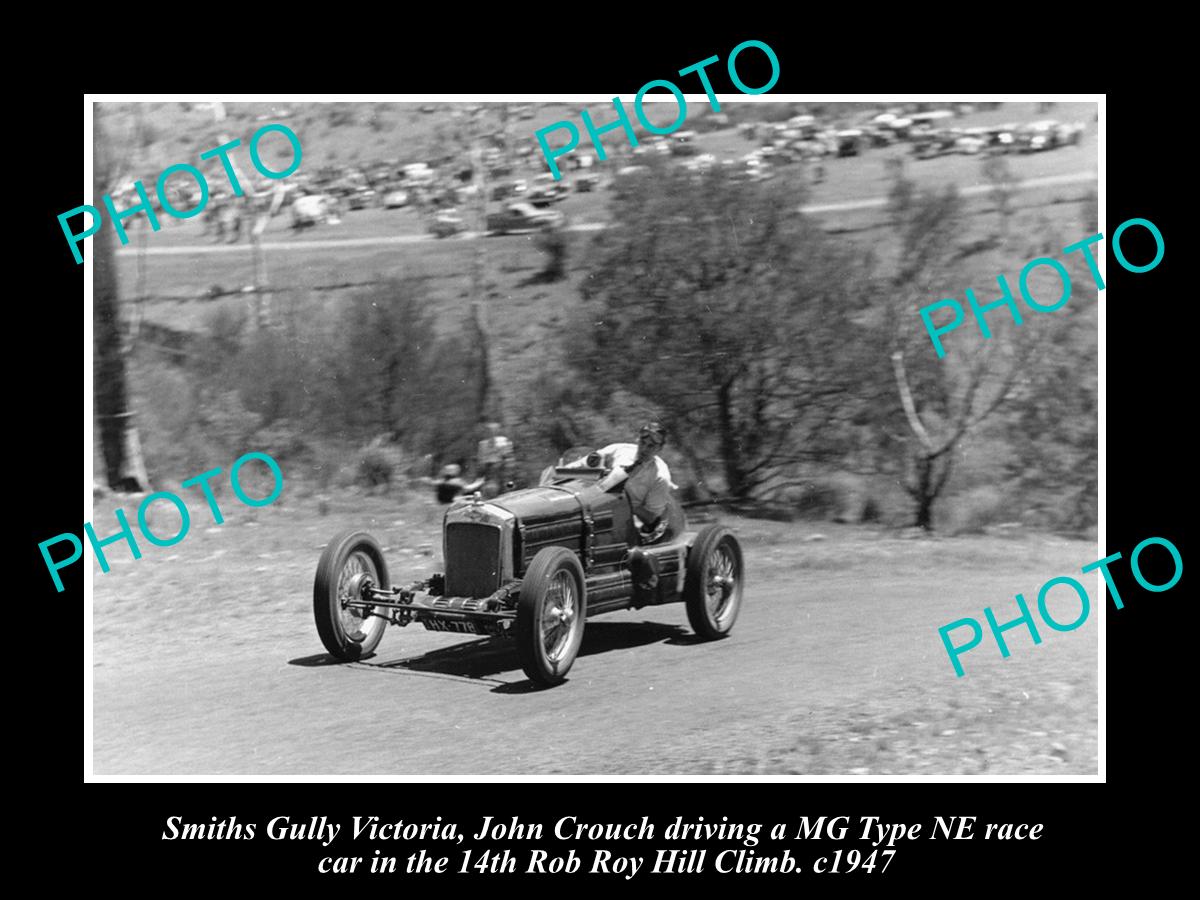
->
left=92, top=497, right=1097, bottom=775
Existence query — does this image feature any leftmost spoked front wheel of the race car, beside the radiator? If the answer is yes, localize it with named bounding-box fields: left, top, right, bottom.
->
left=312, top=530, right=391, bottom=660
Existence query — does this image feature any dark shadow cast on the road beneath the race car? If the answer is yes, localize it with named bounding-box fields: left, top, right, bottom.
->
left=343, top=622, right=686, bottom=694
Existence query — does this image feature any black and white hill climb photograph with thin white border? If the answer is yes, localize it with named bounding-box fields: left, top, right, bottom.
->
left=79, top=95, right=1099, bottom=781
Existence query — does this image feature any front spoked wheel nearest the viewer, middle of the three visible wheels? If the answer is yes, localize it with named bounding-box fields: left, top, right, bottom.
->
left=516, top=547, right=587, bottom=688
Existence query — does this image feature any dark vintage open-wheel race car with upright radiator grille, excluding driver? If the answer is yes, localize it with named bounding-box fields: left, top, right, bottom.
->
left=313, top=451, right=743, bottom=686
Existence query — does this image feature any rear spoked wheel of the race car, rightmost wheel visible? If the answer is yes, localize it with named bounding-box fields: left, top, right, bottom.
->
left=683, top=524, right=744, bottom=640
